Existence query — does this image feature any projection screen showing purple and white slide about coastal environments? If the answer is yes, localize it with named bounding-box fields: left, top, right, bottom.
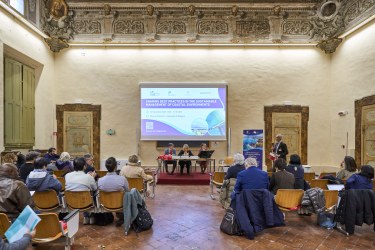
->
left=140, top=84, right=226, bottom=140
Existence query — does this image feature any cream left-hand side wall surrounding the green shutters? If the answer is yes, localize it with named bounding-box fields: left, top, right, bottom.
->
left=0, top=8, right=56, bottom=150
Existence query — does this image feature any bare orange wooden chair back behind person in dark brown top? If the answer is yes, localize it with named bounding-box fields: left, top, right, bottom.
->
left=275, top=189, right=304, bottom=211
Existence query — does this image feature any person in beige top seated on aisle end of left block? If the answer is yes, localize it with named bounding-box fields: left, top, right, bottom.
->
left=120, top=155, right=154, bottom=195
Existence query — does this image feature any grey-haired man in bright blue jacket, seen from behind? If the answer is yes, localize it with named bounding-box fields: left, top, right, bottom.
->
left=232, top=157, right=269, bottom=195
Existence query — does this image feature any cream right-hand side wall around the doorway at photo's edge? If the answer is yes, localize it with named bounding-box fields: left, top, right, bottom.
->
left=329, top=22, right=375, bottom=166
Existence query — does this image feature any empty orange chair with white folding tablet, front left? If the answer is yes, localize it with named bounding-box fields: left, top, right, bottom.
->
left=32, top=209, right=79, bottom=249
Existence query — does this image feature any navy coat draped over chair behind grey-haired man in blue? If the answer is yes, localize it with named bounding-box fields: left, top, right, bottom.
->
left=234, top=189, right=285, bottom=240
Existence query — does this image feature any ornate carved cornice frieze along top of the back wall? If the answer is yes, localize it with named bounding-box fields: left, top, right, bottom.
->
left=41, top=0, right=375, bottom=53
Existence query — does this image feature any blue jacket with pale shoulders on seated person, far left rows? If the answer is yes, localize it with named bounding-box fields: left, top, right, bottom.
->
left=26, top=169, right=62, bottom=192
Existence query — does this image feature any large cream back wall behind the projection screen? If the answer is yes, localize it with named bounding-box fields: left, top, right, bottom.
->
left=55, top=47, right=331, bottom=165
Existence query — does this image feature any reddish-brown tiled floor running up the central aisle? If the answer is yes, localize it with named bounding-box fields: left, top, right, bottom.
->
left=31, top=185, right=375, bottom=250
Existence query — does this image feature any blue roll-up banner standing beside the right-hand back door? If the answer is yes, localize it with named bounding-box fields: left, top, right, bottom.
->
left=243, top=129, right=263, bottom=169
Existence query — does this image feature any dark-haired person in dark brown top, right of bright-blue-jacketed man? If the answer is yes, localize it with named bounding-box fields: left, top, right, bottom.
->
left=269, top=158, right=295, bottom=194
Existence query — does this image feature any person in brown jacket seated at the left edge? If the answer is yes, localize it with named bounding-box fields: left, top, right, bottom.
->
left=0, top=163, right=34, bottom=221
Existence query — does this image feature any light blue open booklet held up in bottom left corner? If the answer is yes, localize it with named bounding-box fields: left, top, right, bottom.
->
left=4, top=206, right=40, bottom=243
